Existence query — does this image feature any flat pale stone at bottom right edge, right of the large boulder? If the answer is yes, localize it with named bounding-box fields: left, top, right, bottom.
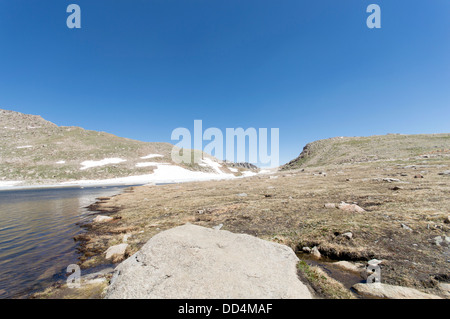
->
left=352, top=283, right=442, bottom=299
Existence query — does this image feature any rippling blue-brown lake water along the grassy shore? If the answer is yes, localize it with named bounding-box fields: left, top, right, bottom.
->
left=0, top=186, right=134, bottom=298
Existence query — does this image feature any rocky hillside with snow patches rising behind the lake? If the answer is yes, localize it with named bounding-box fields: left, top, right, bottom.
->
left=0, top=109, right=253, bottom=184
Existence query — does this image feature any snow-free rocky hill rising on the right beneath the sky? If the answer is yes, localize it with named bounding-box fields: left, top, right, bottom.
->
left=281, top=134, right=450, bottom=170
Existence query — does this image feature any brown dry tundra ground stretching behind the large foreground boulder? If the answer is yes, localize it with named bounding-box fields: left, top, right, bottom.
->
left=71, top=158, right=450, bottom=296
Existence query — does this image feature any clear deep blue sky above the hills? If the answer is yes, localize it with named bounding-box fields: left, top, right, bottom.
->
left=0, top=0, right=450, bottom=163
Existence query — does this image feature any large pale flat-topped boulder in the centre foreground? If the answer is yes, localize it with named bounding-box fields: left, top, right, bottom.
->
left=106, top=224, right=312, bottom=299
